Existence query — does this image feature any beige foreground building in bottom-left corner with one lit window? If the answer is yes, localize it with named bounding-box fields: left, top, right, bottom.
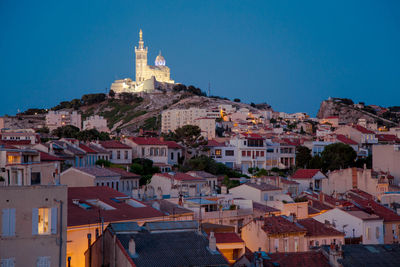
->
left=0, top=185, right=67, bottom=267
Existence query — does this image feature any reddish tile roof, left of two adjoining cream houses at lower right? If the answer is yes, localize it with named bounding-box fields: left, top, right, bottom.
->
left=261, top=216, right=306, bottom=234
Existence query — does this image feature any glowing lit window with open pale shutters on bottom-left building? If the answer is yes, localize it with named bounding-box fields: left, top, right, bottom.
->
left=32, top=208, right=57, bottom=235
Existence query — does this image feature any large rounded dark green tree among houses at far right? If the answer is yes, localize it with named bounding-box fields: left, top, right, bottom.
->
left=321, top=143, right=357, bottom=171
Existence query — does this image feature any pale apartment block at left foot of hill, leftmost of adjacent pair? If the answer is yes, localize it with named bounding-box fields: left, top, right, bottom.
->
left=46, top=110, right=82, bottom=131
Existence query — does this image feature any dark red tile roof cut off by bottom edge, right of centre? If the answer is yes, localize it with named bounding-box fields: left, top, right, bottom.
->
left=264, top=251, right=330, bottom=267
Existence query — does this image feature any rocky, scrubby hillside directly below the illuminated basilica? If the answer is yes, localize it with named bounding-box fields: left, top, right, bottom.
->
left=6, top=87, right=270, bottom=135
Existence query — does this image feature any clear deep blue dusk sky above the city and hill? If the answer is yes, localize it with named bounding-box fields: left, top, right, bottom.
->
left=0, top=0, right=400, bottom=115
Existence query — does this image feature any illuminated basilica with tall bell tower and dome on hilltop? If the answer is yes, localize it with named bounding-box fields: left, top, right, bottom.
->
left=111, top=30, right=175, bottom=93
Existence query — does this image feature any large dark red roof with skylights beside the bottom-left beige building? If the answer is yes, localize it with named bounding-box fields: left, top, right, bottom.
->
left=67, top=186, right=164, bottom=227
